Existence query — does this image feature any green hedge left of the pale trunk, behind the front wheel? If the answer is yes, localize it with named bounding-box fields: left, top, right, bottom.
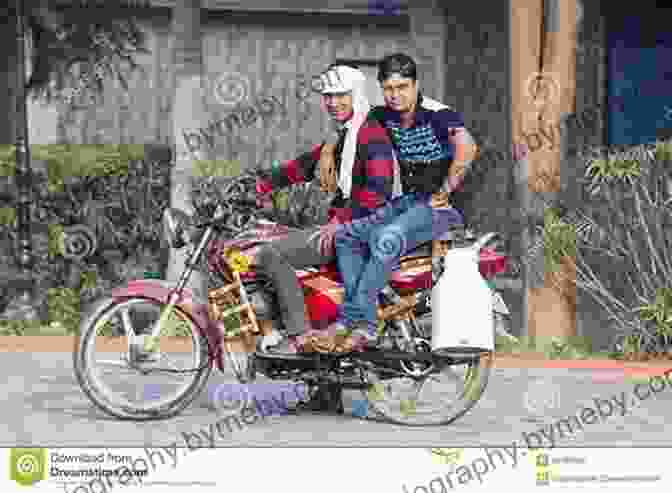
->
left=0, top=144, right=170, bottom=334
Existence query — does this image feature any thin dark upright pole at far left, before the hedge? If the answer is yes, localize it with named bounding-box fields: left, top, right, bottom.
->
left=8, top=0, right=38, bottom=320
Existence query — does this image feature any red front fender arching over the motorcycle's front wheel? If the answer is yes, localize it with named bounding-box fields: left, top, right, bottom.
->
left=112, top=279, right=221, bottom=368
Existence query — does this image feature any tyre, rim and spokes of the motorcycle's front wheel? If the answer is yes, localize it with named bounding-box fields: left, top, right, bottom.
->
left=73, top=297, right=212, bottom=421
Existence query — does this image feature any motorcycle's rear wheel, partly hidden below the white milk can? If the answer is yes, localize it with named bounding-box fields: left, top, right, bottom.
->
left=362, top=352, right=494, bottom=426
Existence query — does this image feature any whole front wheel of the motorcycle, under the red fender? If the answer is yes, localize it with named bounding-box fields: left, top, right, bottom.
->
left=74, top=297, right=212, bottom=420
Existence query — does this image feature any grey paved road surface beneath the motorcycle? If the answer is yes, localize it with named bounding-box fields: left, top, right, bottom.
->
left=5, top=353, right=672, bottom=447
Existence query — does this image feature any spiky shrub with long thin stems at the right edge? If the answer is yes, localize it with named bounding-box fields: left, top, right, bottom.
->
left=560, top=138, right=672, bottom=358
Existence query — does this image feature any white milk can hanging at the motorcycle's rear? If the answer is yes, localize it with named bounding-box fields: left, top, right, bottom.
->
left=432, top=233, right=496, bottom=356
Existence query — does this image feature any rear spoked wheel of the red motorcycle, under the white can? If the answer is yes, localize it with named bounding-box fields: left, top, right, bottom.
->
left=363, top=341, right=494, bottom=426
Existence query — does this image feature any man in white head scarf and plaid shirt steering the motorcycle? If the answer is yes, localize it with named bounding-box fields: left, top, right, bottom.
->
left=255, top=65, right=400, bottom=354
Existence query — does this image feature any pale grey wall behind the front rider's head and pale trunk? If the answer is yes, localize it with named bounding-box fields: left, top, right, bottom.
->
left=32, top=9, right=414, bottom=173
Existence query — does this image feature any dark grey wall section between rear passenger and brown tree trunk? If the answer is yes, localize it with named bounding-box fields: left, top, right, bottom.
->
left=444, top=1, right=514, bottom=241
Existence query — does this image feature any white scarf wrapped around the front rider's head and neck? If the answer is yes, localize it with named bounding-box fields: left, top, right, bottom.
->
left=320, top=65, right=401, bottom=198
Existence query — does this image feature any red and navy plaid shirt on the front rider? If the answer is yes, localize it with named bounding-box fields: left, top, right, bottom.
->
left=270, top=119, right=394, bottom=223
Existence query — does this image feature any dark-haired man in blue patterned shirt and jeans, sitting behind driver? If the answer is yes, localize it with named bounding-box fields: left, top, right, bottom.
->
left=318, top=54, right=476, bottom=348
